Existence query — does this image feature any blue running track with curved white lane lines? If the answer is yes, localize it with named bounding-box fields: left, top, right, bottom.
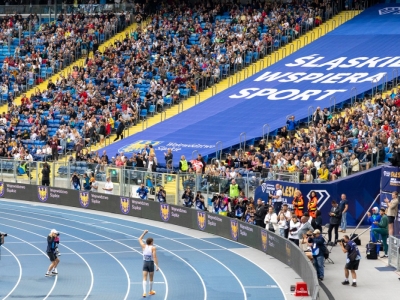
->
left=0, top=201, right=285, bottom=300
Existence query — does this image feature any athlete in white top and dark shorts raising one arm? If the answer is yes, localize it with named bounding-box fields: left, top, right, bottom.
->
left=139, top=230, right=158, bottom=298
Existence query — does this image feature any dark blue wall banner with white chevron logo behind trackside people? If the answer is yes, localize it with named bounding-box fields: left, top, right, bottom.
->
left=255, top=168, right=380, bottom=226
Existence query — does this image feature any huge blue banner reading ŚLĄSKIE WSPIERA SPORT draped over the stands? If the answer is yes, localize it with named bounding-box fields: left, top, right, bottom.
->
left=101, top=4, right=400, bottom=166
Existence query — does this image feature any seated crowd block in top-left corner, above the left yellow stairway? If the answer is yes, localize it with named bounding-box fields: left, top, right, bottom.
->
left=0, top=13, right=130, bottom=104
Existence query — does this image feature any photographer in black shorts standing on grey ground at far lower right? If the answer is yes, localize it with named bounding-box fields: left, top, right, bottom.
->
left=340, top=235, right=361, bottom=287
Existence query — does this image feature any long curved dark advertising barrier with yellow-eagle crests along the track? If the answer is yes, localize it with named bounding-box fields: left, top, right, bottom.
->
left=0, top=182, right=319, bottom=300
